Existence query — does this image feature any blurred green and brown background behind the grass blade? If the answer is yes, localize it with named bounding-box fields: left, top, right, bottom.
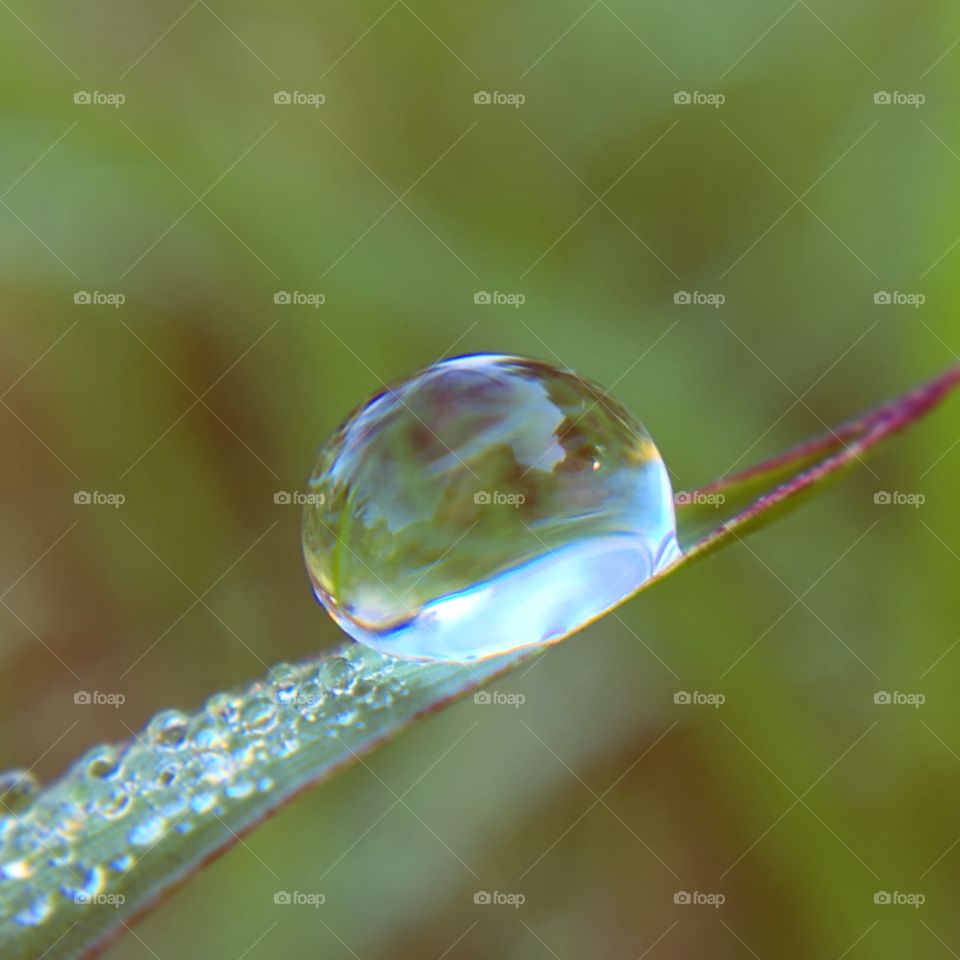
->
left=0, top=0, right=960, bottom=960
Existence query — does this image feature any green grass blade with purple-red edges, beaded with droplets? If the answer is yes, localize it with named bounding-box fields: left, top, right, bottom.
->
left=0, top=367, right=960, bottom=960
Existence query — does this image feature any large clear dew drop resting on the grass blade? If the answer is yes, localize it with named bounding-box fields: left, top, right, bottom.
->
left=303, top=354, right=679, bottom=661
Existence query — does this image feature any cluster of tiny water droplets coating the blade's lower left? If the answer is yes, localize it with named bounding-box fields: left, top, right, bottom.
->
left=0, top=646, right=409, bottom=926
